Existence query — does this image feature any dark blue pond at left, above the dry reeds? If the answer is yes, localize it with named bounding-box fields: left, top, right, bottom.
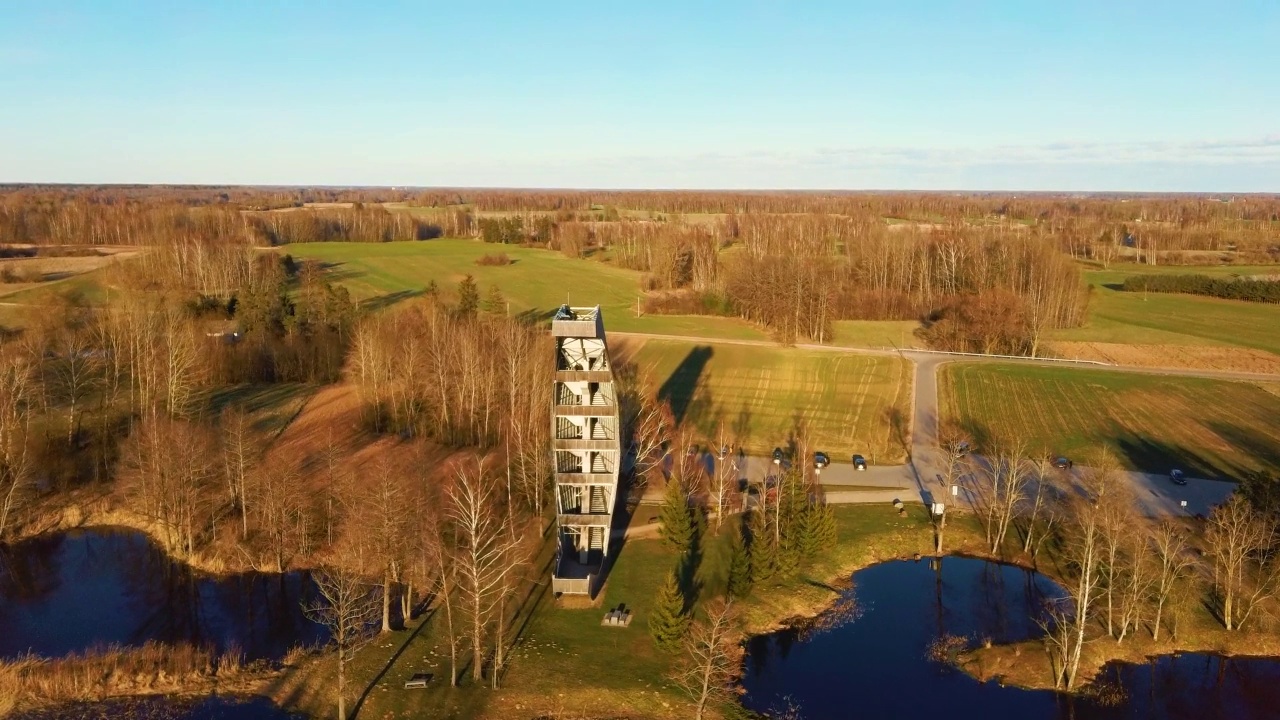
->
left=0, top=529, right=326, bottom=660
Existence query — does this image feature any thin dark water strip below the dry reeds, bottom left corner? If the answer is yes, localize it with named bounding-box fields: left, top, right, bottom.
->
left=10, top=697, right=306, bottom=720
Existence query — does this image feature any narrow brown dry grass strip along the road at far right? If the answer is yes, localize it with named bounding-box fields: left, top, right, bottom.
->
left=1048, top=341, right=1280, bottom=374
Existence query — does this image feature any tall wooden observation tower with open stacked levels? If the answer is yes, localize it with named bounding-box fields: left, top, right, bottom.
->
left=552, top=305, right=622, bottom=596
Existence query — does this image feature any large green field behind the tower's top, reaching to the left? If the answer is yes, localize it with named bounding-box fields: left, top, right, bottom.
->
left=283, top=240, right=767, bottom=340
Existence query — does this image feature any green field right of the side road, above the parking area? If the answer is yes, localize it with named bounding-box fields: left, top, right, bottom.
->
left=941, top=364, right=1280, bottom=478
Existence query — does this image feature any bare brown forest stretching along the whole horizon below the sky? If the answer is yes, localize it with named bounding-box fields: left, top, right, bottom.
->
left=0, top=186, right=1280, bottom=354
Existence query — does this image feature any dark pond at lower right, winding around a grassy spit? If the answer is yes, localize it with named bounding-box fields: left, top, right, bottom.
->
left=742, top=557, right=1280, bottom=720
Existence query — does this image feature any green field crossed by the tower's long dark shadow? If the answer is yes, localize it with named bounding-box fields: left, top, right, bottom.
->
left=632, top=340, right=911, bottom=462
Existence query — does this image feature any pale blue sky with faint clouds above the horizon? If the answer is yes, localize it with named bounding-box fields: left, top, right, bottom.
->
left=0, top=0, right=1280, bottom=192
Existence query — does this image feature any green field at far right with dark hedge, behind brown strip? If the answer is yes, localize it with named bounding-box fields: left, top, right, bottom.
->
left=1052, top=265, right=1280, bottom=354
